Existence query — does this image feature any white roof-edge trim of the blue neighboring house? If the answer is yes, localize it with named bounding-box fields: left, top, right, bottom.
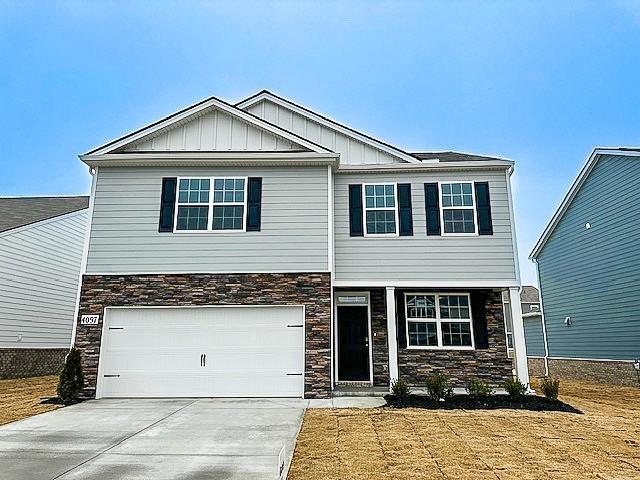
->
left=529, top=147, right=640, bottom=260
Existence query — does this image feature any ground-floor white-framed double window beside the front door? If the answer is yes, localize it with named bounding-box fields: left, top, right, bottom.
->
left=405, top=293, right=474, bottom=350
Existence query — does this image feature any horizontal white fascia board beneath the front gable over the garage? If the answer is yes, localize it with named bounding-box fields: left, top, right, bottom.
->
left=80, top=152, right=340, bottom=171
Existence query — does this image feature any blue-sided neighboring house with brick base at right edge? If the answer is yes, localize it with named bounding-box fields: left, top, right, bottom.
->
left=530, top=148, right=640, bottom=385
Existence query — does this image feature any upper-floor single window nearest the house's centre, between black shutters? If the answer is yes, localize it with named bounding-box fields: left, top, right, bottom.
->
left=363, top=183, right=398, bottom=235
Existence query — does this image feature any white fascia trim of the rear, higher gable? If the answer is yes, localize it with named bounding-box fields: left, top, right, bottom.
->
left=236, top=92, right=422, bottom=163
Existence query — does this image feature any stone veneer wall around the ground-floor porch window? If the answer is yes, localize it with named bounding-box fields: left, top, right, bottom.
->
left=396, top=289, right=513, bottom=387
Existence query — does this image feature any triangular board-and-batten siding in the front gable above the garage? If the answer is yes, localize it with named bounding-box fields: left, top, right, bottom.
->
left=124, top=109, right=306, bottom=152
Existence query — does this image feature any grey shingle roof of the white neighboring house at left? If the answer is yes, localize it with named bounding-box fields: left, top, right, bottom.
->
left=0, top=195, right=89, bottom=233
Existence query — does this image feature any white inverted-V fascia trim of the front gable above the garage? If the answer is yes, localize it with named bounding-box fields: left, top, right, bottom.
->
left=86, top=97, right=332, bottom=155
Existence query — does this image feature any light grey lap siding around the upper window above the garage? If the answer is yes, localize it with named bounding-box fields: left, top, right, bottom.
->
left=87, top=166, right=328, bottom=274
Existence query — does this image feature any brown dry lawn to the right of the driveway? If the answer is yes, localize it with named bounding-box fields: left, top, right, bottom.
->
left=289, top=382, right=640, bottom=480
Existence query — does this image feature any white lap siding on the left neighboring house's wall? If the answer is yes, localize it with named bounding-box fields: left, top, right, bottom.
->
left=0, top=209, right=88, bottom=348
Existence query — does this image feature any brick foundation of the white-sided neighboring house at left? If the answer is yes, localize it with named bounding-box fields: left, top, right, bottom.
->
left=0, top=348, right=69, bottom=379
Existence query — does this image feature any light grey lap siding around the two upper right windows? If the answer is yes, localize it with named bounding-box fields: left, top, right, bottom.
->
left=334, top=170, right=516, bottom=284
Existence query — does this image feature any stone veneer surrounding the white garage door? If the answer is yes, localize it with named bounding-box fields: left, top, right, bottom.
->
left=75, top=273, right=331, bottom=398
